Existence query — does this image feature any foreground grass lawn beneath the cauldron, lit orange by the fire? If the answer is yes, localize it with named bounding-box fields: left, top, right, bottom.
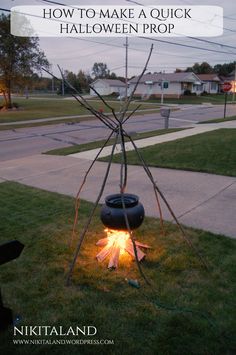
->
left=0, top=182, right=236, bottom=355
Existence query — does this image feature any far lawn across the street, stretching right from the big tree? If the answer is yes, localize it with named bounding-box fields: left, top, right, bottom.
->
left=0, top=98, right=159, bottom=123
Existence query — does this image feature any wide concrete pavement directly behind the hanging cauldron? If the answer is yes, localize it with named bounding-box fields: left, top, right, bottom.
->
left=0, top=155, right=236, bottom=237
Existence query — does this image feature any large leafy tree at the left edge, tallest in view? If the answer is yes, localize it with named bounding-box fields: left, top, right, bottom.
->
left=0, top=14, right=48, bottom=108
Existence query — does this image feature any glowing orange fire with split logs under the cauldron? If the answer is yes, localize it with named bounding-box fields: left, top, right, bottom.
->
left=96, top=229, right=149, bottom=268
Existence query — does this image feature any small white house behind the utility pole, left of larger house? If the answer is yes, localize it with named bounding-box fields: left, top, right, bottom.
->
left=90, top=79, right=125, bottom=96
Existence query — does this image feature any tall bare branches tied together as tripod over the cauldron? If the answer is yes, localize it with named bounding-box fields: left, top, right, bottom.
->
left=44, top=45, right=207, bottom=286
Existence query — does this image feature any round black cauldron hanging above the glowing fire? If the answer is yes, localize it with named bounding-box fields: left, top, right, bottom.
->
left=101, top=193, right=145, bottom=231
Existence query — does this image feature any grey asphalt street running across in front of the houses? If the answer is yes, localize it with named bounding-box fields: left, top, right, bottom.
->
left=0, top=105, right=236, bottom=161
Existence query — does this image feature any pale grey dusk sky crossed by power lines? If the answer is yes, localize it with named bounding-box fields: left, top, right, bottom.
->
left=0, top=0, right=236, bottom=77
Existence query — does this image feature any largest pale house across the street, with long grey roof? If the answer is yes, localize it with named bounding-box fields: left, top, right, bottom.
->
left=129, top=72, right=202, bottom=98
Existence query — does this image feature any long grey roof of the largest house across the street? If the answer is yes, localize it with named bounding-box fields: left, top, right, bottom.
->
left=129, top=72, right=201, bottom=84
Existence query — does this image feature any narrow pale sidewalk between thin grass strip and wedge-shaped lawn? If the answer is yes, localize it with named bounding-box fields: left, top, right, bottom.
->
left=70, top=121, right=236, bottom=160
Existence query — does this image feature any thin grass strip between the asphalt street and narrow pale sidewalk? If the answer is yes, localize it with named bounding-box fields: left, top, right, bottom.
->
left=44, top=128, right=186, bottom=155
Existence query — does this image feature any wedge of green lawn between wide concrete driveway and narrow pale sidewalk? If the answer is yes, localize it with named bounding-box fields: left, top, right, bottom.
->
left=101, top=129, right=236, bottom=176
